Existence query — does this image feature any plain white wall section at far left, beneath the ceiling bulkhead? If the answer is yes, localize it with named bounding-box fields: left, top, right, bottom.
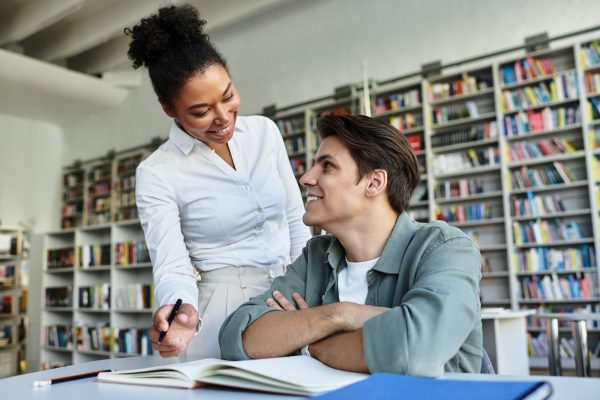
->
left=0, top=114, right=63, bottom=232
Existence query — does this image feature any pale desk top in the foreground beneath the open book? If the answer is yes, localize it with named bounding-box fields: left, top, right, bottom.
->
left=0, top=357, right=600, bottom=400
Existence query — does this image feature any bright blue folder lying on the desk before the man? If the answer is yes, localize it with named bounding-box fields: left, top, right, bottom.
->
left=312, top=373, right=552, bottom=400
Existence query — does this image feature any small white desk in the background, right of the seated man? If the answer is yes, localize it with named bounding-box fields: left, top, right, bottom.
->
left=481, top=310, right=535, bottom=375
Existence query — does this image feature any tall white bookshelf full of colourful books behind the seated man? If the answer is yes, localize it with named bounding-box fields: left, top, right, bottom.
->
left=268, top=40, right=600, bottom=376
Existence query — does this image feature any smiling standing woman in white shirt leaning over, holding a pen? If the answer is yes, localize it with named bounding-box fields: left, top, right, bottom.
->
left=125, top=5, right=310, bottom=358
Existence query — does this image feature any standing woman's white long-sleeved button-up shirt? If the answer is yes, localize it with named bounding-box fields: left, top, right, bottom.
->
left=136, top=116, right=310, bottom=305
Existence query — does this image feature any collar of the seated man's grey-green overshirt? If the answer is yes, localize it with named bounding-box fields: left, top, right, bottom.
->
left=327, top=212, right=418, bottom=274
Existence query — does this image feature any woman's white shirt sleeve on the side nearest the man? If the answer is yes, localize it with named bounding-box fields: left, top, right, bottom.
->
left=271, top=121, right=311, bottom=262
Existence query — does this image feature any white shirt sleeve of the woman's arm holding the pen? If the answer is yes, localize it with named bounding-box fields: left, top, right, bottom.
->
left=135, top=164, right=198, bottom=309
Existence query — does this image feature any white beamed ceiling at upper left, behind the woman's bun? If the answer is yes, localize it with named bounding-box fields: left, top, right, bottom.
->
left=0, top=0, right=284, bottom=76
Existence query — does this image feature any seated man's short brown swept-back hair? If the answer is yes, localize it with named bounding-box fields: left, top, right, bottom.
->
left=317, top=115, right=419, bottom=214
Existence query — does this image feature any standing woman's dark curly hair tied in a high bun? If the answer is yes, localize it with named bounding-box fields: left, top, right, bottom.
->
left=125, top=4, right=227, bottom=107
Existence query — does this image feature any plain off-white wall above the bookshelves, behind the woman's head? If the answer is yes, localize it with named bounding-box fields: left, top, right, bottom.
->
left=65, top=0, right=600, bottom=163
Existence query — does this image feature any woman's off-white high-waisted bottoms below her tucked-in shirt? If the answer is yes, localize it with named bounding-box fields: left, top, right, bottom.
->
left=185, top=266, right=285, bottom=359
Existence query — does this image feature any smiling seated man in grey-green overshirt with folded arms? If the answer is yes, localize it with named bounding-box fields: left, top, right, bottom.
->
left=219, top=116, right=482, bottom=376
